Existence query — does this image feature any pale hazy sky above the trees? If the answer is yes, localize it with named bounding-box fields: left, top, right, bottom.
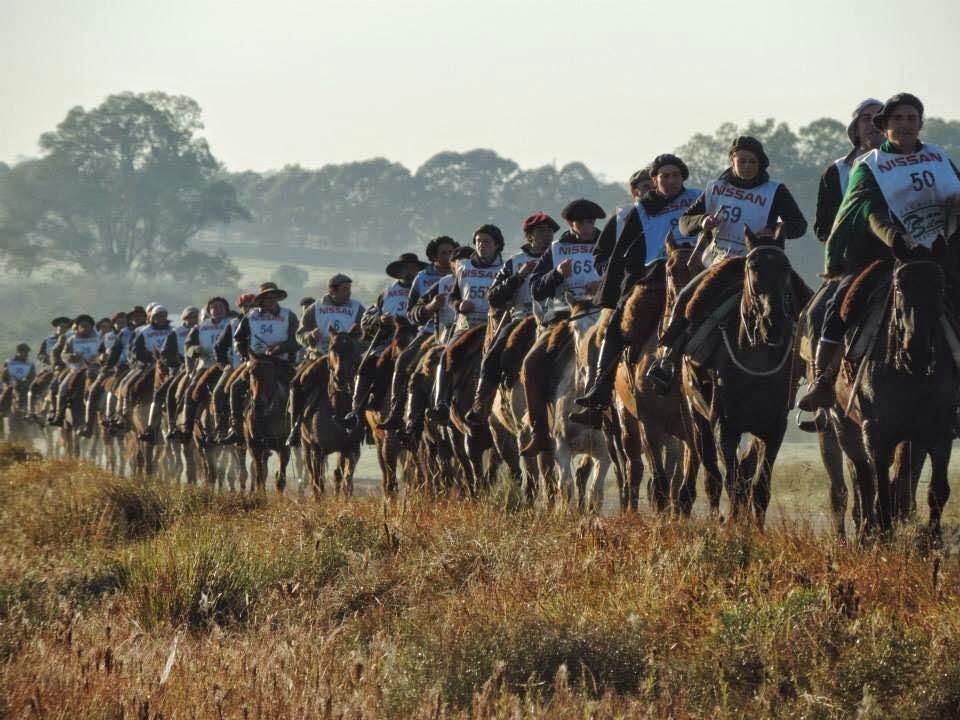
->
left=0, top=0, right=960, bottom=179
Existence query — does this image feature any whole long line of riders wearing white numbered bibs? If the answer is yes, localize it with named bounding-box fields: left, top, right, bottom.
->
left=3, top=93, right=960, bottom=512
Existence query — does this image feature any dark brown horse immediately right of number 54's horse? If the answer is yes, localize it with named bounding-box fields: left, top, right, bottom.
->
left=300, top=328, right=361, bottom=499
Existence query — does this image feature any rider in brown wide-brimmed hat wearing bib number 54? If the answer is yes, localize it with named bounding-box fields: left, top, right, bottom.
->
left=221, top=282, right=300, bottom=445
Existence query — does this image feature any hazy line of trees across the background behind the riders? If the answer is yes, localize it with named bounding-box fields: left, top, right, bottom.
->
left=0, top=93, right=960, bottom=285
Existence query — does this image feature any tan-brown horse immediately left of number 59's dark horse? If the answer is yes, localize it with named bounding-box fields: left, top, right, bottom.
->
left=608, top=235, right=696, bottom=516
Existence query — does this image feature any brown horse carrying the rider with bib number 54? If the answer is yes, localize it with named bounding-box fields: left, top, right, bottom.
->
left=243, top=355, right=290, bottom=494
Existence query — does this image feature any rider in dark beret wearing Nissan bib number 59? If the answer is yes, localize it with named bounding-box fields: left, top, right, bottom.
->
left=647, top=135, right=807, bottom=394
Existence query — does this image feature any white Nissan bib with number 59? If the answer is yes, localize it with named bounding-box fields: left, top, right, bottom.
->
left=704, top=180, right=780, bottom=264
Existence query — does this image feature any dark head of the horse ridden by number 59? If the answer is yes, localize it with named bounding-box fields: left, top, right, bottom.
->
left=740, top=225, right=792, bottom=345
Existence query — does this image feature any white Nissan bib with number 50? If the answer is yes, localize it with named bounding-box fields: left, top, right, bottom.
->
left=861, top=144, right=960, bottom=247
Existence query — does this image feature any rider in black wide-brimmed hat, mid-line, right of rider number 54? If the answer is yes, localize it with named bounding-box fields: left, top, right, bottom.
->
left=344, top=253, right=427, bottom=431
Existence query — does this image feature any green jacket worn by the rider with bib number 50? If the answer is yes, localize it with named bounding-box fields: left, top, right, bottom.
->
left=824, top=140, right=960, bottom=273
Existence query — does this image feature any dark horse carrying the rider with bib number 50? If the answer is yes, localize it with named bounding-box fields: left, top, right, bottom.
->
left=831, top=242, right=958, bottom=541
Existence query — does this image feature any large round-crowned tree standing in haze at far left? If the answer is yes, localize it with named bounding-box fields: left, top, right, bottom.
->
left=0, top=93, right=250, bottom=279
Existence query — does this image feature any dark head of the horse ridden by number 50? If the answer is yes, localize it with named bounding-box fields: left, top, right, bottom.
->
left=891, top=260, right=946, bottom=374
